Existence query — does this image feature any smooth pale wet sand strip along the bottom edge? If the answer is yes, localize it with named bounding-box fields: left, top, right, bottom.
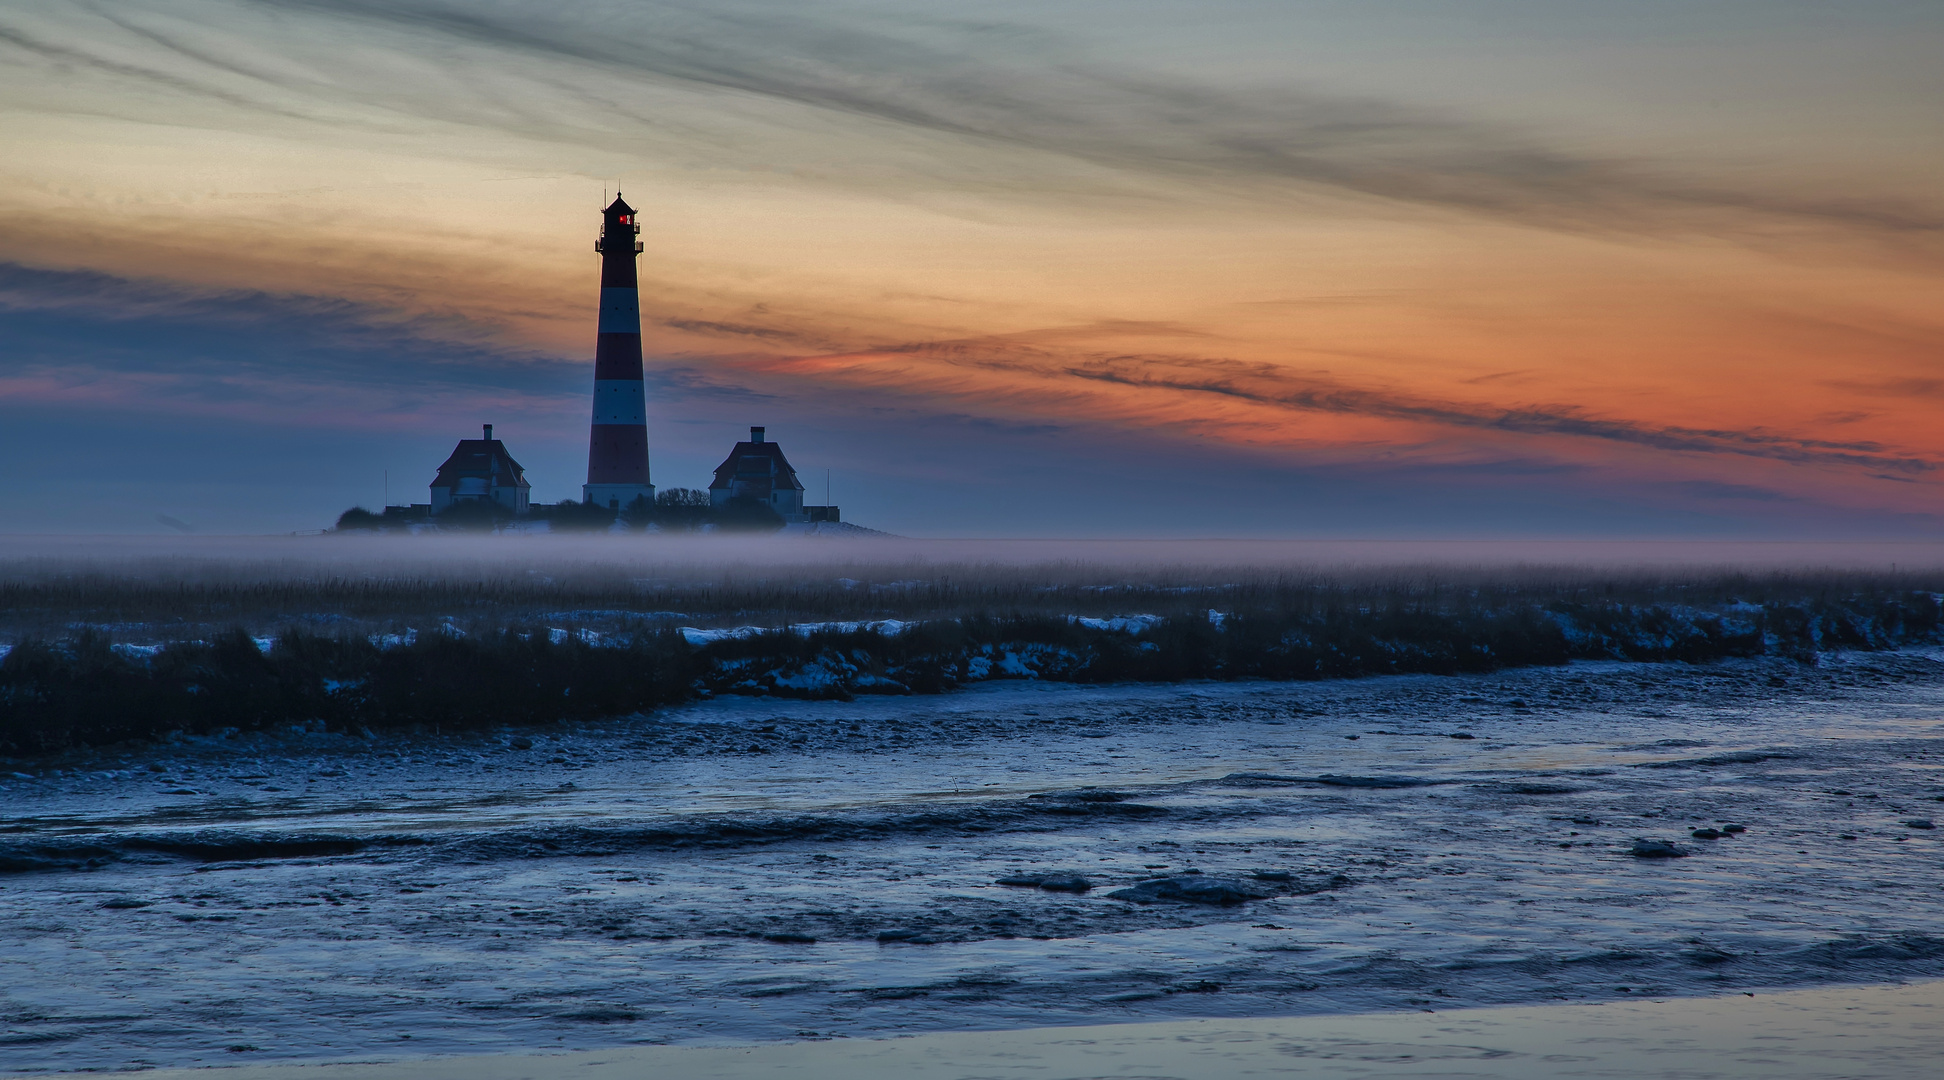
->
left=56, top=981, right=1944, bottom=1080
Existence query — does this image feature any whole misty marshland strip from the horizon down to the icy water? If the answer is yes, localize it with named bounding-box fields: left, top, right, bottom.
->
left=0, top=536, right=1944, bottom=754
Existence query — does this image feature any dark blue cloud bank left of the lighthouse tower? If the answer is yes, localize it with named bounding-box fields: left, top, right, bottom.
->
left=0, top=262, right=585, bottom=425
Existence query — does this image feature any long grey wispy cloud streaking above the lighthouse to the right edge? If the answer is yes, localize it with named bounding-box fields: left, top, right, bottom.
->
left=0, top=0, right=1944, bottom=237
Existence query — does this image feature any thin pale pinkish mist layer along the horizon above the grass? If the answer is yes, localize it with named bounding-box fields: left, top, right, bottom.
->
left=0, top=534, right=1944, bottom=583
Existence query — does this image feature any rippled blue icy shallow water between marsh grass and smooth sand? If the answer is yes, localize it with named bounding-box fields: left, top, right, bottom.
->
left=0, top=653, right=1944, bottom=1070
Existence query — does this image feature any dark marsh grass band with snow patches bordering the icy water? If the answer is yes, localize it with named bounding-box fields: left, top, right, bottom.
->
left=0, top=567, right=1944, bottom=754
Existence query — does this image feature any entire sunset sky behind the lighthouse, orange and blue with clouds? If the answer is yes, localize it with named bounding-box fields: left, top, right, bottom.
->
left=0, top=0, right=1944, bottom=540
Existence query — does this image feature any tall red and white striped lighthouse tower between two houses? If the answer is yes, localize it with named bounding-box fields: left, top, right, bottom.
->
left=581, top=192, right=655, bottom=509
